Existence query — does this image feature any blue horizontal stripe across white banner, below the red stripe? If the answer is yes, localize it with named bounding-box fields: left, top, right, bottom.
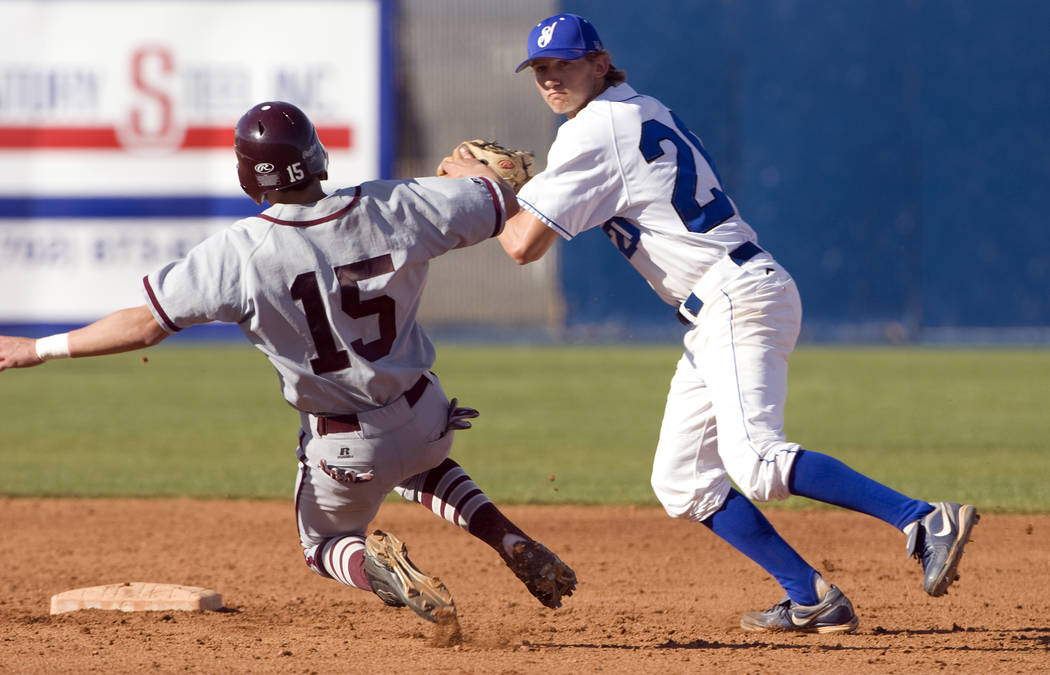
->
left=0, top=195, right=264, bottom=219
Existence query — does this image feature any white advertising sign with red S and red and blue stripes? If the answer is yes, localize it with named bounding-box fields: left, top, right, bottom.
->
left=0, top=0, right=391, bottom=322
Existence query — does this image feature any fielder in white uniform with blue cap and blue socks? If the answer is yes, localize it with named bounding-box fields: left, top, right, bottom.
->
left=442, top=14, right=978, bottom=633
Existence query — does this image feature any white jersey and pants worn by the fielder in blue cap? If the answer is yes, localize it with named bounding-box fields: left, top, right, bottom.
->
left=518, top=84, right=801, bottom=521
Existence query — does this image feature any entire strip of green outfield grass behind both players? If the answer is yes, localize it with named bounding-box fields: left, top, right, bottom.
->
left=0, top=344, right=1050, bottom=511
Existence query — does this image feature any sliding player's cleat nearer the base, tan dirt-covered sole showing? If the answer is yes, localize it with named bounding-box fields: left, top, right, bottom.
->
left=364, top=530, right=456, bottom=624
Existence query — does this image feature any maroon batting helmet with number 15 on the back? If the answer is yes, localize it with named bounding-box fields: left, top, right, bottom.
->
left=233, top=101, right=328, bottom=204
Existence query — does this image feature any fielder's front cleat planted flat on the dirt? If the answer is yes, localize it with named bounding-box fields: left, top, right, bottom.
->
left=740, top=575, right=860, bottom=633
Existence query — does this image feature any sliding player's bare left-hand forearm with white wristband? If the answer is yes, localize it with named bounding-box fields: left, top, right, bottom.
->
left=0, top=304, right=168, bottom=371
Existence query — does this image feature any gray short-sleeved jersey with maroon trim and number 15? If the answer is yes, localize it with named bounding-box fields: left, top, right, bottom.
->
left=143, top=177, right=506, bottom=415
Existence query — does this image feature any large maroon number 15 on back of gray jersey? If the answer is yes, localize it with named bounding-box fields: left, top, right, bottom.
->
left=290, top=253, right=397, bottom=375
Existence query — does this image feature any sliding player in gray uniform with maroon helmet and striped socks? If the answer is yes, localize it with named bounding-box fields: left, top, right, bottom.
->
left=0, top=101, right=575, bottom=621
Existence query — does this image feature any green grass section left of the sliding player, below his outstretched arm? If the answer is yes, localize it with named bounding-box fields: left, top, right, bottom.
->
left=0, top=346, right=298, bottom=497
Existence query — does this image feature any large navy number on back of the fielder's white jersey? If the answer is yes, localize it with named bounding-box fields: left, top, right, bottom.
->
left=638, top=112, right=734, bottom=233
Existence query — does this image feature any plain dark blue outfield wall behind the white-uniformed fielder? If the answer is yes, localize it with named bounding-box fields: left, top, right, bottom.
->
left=563, top=0, right=1050, bottom=341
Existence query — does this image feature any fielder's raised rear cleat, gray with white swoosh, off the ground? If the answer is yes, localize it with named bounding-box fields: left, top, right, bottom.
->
left=904, top=502, right=981, bottom=597
